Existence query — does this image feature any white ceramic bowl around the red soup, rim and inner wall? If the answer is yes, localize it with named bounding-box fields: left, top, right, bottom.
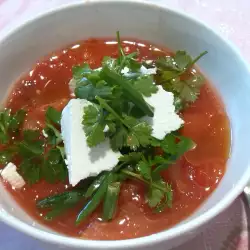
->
left=0, top=0, right=250, bottom=250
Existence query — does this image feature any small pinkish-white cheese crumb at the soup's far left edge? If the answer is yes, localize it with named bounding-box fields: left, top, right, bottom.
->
left=1, top=162, right=25, bottom=189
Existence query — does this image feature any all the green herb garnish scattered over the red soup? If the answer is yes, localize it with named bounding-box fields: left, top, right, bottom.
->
left=0, top=32, right=207, bottom=225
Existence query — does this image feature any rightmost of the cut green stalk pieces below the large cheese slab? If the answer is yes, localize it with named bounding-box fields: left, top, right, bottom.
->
left=102, top=182, right=121, bottom=221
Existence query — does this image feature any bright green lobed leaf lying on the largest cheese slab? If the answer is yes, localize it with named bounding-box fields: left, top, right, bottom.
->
left=82, top=104, right=105, bottom=147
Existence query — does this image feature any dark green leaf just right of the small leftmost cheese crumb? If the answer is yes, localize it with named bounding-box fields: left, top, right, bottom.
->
left=19, top=159, right=41, bottom=185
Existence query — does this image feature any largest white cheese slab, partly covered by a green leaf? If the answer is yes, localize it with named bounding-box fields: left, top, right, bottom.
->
left=61, top=99, right=121, bottom=186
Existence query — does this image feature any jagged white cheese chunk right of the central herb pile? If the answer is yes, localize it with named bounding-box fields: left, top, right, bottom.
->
left=143, top=86, right=184, bottom=140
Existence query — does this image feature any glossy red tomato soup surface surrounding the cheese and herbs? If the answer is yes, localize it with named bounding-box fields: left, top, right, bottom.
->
left=2, top=39, right=230, bottom=240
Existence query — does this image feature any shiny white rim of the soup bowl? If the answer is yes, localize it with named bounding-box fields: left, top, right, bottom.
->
left=0, top=0, right=250, bottom=249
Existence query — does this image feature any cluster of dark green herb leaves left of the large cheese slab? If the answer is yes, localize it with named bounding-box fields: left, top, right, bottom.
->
left=0, top=107, right=68, bottom=185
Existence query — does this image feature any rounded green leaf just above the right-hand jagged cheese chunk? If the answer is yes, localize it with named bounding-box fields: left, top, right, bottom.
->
left=134, top=75, right=158, bottom=97
